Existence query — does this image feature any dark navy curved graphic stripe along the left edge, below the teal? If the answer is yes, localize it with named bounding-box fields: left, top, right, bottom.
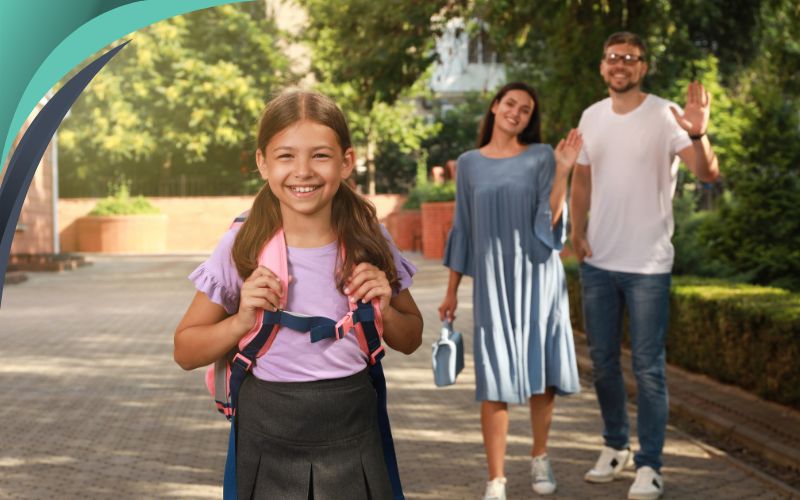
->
left=0, top=42, right=128, bottom=303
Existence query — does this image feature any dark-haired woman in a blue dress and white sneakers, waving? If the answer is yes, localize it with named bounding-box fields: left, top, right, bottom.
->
left=439, top=83, right=582, bottom=499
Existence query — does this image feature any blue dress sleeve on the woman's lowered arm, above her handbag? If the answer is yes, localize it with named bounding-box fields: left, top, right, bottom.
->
left=444, top=158, right=475, bottom=276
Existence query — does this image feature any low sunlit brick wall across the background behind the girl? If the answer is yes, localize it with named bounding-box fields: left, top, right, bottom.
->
left=58, top=194, right=405, bottom=253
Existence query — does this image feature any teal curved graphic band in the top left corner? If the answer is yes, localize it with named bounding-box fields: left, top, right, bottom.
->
left=0, top=0, right=251, bottom=173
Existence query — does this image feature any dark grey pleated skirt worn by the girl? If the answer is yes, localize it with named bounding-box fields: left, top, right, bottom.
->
left=236, top=370, right=392, bottom=500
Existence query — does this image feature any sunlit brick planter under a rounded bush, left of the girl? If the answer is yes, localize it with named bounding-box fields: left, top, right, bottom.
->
left=75, top=214, right=167, bottom=253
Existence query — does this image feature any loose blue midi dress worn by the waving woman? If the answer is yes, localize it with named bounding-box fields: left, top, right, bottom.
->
left=444, top=144, right=580, bottom=403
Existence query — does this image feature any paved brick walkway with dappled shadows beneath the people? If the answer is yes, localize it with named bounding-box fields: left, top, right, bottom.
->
left=0, top=257, right=787, bottom=500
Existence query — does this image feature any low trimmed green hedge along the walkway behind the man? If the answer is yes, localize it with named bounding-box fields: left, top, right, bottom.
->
left=565, top=262, right=800, bottom=408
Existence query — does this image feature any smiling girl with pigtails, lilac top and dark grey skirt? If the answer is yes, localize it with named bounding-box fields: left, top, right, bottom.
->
left=175, top=91, right=422, bottom=500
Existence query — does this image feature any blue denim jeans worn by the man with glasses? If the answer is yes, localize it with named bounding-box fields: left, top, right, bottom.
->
left=580, top=262, right=672, bottom=471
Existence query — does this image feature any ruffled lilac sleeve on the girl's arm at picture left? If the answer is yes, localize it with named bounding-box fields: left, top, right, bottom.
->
left=189, top=229, right=242, bottom=314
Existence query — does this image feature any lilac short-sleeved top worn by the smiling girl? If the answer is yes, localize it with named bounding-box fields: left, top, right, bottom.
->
left=189, top=227, right=417, bottom=382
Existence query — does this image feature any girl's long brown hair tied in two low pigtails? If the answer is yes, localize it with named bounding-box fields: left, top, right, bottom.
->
left=232, top=90, right=400, bottom=293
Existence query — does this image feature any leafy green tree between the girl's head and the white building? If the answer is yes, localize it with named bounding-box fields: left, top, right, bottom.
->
left=298, top=0, right=446, bottom=193
